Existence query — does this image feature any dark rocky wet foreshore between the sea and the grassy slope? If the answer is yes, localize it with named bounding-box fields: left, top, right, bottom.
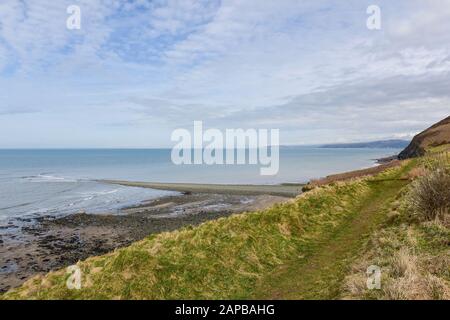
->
left=0, top=190, right=292, bottom=292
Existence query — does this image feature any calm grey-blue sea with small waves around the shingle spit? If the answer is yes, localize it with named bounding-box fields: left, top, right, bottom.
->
left=0, top=147, right=400, bottom=222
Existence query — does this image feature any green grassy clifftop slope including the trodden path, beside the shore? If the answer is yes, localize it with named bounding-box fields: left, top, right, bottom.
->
left=1, top=161, right=414, bottom=299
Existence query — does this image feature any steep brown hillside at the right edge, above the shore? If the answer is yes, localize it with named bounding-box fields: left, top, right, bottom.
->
left=398, top=116, right=450, bottom=159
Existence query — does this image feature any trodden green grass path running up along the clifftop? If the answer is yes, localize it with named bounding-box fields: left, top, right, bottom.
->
left=254, top=165, right=411, bottom=299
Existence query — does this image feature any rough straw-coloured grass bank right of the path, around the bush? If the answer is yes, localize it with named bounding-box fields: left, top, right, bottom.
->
left=340, top=149, right=450, bottom=300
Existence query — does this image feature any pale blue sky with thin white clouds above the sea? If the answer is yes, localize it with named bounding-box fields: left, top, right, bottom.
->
left=0, top=0, right=450, bottom=148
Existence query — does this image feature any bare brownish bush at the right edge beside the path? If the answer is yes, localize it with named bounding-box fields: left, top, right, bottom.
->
left=408, top=168, right=450, bottom=221
